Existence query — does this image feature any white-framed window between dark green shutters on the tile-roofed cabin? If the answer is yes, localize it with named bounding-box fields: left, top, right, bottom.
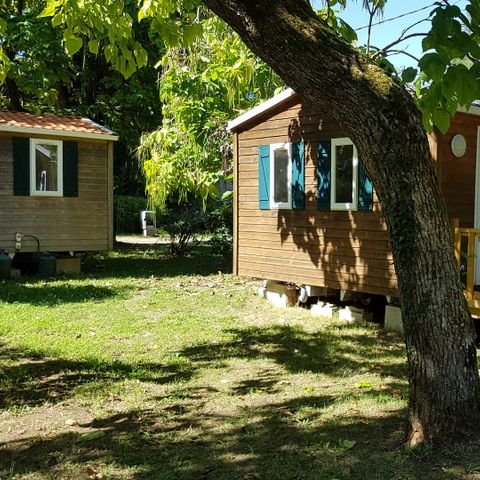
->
left=30, top=138, right=63, bottom=196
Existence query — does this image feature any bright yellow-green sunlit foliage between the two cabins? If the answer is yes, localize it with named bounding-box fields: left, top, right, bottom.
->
left=139, top=11, right=282, bottom=205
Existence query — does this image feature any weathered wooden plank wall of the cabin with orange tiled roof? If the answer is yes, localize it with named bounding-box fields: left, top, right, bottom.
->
left=0, top=135, right=112, bottom=252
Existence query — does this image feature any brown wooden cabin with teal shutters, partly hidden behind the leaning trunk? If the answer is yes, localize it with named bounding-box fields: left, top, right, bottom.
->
left=229, top=90, right=480, bottom=310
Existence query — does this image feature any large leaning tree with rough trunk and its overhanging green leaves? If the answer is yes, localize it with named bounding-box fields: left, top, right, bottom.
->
left=28, top=0, right=480, bottom=445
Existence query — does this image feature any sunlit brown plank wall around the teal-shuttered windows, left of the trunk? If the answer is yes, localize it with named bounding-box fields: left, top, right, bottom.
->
left=234, top=100, right=397, bottom=295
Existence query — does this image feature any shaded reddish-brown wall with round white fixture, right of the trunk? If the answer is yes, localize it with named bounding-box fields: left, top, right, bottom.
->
left=437, top=113, right=480, bottom=228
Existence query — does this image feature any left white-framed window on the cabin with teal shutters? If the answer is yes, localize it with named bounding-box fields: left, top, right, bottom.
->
left=270, top=143, right=292, bottom=209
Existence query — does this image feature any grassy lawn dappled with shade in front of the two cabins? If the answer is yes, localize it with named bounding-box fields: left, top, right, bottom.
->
left=0, top=246, right=480, bottom=480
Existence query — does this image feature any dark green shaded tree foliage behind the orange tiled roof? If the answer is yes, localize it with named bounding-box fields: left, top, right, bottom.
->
left=0, top=0, right=164, bottom=195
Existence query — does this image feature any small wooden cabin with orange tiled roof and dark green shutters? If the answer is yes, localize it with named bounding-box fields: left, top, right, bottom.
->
left=0, top=112, right=118, bottom=254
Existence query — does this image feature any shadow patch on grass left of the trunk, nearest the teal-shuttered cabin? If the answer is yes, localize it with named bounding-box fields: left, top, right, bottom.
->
left=180, top=325, right=407, bottom=378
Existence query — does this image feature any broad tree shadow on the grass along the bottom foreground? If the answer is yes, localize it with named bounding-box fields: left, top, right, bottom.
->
left=0, top=396, right=478, bottom=480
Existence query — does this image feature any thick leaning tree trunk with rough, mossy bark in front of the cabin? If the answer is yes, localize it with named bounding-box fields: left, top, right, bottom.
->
left=204, top=0, right=480, bottom=445
